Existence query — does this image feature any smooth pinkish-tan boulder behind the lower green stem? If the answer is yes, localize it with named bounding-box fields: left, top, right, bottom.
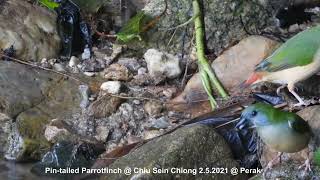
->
left=169, top=36, right=278, bottom=117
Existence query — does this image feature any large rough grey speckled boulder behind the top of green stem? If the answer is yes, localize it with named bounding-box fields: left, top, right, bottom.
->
left=126, top=0, right=316, bottom=55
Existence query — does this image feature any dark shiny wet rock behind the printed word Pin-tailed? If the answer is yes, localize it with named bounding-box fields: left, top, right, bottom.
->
left=31, top=141, right=104, bottom=178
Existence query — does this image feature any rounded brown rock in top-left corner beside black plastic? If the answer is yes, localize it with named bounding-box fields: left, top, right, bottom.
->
left=0, top=0, right=60, bottom=61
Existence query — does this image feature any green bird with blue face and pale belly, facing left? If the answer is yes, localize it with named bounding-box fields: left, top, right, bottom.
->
left=236, top=103, right=312, bottom=171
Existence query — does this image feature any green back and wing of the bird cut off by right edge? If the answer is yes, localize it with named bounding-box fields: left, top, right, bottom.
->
left=255, top=26, right=320, bottom=72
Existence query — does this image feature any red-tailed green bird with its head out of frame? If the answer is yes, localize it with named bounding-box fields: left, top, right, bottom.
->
left=243, top=26, right=320, bottom=106
